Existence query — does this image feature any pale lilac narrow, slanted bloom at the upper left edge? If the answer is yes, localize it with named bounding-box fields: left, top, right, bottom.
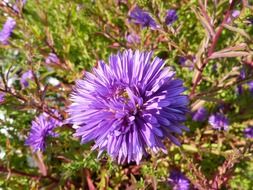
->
left=0, top=17, right=16, bottom=45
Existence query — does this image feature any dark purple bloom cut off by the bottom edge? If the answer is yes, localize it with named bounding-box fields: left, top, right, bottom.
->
left=168, top=170, right=190, bottom=190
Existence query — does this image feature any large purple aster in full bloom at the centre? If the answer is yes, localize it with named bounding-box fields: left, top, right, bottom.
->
left=68, top=50, right=188, bottom=164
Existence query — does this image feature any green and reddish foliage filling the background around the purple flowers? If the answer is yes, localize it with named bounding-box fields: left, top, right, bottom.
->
left=0, top=0, right=253, bottom=189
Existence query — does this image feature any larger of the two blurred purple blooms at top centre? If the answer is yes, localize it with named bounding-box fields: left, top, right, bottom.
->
left=129, top=6, right=159, bottom=30
